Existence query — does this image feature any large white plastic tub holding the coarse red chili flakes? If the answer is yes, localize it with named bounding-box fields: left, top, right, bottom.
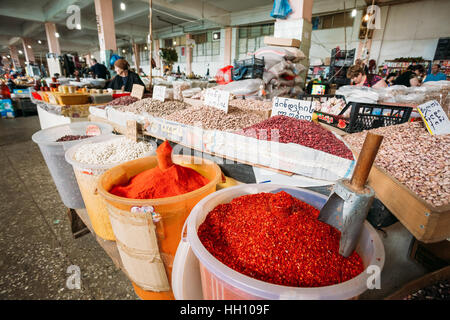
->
left=186, top=184, right=384, bottom=300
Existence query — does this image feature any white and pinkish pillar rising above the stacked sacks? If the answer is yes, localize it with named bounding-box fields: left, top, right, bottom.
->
left=274, top=0, right=313, bottom=73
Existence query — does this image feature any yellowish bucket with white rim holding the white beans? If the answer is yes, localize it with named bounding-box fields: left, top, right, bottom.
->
left=66, top=135, right=155, bottom=241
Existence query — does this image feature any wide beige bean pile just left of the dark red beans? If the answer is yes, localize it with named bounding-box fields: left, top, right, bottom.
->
left=164, top=106, right=264, bottom=131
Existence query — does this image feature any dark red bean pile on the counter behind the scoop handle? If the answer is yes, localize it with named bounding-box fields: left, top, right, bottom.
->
left=236, top=116, right=353, bottom=160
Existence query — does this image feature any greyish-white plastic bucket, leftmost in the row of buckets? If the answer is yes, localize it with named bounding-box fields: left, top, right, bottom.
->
left=31, top=121, right=113, bottom=209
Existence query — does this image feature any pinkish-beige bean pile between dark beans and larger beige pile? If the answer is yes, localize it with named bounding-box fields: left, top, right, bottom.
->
left=117, top=98, right=190, bottom=117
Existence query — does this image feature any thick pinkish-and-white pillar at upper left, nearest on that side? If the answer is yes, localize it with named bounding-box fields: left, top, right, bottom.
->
left=95, top=0, right=117, bottom=65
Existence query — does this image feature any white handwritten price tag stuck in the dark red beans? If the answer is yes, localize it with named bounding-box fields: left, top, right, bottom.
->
left=272, top=97, right=314, bottom=121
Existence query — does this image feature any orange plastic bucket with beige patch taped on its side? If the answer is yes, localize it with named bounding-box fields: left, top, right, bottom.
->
left=98, top=155, right=222, bottom=300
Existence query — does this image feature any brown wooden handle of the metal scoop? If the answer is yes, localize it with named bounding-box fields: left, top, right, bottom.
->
left=350, top=132, right=383, bottom=190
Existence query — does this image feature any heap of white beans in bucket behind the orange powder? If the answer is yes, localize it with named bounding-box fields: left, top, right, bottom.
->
left=73, top=137, right=155, bottom=165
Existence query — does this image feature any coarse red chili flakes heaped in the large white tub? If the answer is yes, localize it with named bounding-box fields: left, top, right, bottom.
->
left=198, top=191, right=364, bottom=287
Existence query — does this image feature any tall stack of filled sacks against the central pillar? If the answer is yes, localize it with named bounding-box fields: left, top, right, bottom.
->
left=254, top=46, right=306, bottom=98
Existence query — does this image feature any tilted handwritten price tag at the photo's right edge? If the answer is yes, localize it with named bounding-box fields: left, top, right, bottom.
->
left=417, top=100, right=450, bottom=135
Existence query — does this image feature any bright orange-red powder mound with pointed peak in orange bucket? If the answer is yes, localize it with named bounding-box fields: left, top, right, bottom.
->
left=110, top=141, right=209, bottom=199
